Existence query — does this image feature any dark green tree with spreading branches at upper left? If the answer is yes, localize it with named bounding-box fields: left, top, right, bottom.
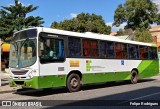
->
left=0, top=0, right=44, bottom=40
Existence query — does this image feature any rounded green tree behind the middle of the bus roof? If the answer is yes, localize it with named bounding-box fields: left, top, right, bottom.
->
left=51, top=13, right=111, bottom=34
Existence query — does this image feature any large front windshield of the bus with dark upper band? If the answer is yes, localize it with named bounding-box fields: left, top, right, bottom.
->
left=9, top=29, right=37, bottom=68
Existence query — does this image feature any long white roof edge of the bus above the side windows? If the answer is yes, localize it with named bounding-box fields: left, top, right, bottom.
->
left=21, top=27, right=155, bottom=46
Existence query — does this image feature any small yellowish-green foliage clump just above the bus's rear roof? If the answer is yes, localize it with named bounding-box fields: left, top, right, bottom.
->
left=135, top=29, right=153, bottom=42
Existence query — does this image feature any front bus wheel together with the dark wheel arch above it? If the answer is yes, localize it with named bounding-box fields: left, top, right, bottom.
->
left=66, top=70, right=82, bottom=92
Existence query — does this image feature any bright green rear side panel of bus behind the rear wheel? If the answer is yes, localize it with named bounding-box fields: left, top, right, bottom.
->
left=138, top=60, right=159, bottom=78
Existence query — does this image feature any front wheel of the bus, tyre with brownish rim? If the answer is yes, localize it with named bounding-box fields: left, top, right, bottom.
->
left=67, top=73, right=81, bottom=92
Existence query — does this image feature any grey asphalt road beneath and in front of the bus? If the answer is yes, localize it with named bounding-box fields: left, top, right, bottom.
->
left=0, top=76, right=160, bottom=109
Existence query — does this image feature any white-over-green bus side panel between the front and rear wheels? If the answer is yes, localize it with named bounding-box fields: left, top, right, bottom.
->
left=82, top=59, right=141, bottom=84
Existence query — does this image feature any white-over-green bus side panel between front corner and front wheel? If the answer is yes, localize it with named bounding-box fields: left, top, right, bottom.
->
left=39, top=62, right=67, bottom=88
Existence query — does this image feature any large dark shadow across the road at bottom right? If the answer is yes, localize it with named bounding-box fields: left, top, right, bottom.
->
left=43, top=87, right=160, bottom=109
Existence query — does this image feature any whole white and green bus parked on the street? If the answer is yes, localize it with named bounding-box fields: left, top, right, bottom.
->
left=9, top=27, right=159, bottom=92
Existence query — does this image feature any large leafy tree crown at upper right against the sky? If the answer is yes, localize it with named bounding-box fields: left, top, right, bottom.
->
left=113, top=0, right=160, bottom=30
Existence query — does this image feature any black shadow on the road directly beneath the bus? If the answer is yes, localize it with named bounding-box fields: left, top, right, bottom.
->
left=14, top=79, right=155, bottom=97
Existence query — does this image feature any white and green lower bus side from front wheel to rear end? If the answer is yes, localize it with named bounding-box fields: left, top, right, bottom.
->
left=82, top=60, right=159, bottom=84
